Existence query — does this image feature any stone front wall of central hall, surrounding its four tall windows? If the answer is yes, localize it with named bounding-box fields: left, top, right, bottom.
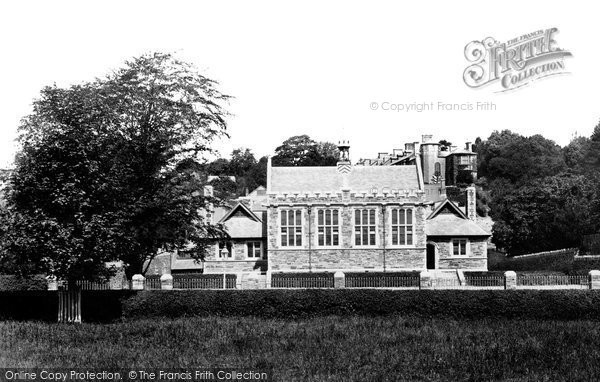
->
left=267, top=192, right=431, bottom=271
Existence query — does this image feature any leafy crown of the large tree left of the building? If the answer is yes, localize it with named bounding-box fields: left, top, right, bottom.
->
left=0, top=53, right=227, bottom=280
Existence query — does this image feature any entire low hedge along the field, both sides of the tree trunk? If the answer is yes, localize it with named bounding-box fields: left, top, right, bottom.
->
left=0, top=289, right=600, bottom=322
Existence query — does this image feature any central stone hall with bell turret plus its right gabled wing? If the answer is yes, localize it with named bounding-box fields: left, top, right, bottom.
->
left=267, top=144, right=490, bottom=272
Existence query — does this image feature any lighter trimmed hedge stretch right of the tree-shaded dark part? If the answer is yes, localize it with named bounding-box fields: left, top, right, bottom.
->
left=122, top=289, right=600, bottom=319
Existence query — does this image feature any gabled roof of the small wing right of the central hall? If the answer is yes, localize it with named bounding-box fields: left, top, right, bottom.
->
left=425, top=199, right=491, bottom=237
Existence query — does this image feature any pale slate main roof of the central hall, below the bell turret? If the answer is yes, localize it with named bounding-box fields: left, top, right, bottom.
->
left=269, top=166, right=420, bottom=193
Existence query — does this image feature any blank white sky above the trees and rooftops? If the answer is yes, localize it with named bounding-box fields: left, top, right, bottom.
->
left=0, top=0, right=600, bottom=167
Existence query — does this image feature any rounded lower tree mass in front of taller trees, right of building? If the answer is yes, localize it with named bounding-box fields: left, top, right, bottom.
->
left=491, top=175, right=600, bottom=255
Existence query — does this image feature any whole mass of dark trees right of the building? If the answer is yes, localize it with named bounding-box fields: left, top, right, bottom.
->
left=476, top=126, right=600, bottom=254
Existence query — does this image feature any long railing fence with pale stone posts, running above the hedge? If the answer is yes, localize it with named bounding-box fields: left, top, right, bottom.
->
left=48, top=271, right=600, bottom=291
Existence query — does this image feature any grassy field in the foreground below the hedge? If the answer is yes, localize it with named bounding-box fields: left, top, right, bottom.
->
left=0, top=316, right=600, bottom=381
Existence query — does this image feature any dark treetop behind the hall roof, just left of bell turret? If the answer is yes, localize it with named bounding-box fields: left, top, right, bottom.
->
left=272, top=135, right=339, bottom=166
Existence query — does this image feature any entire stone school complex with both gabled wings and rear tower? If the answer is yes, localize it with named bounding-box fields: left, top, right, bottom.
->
left=148, top=136, right=490, bottom=274
